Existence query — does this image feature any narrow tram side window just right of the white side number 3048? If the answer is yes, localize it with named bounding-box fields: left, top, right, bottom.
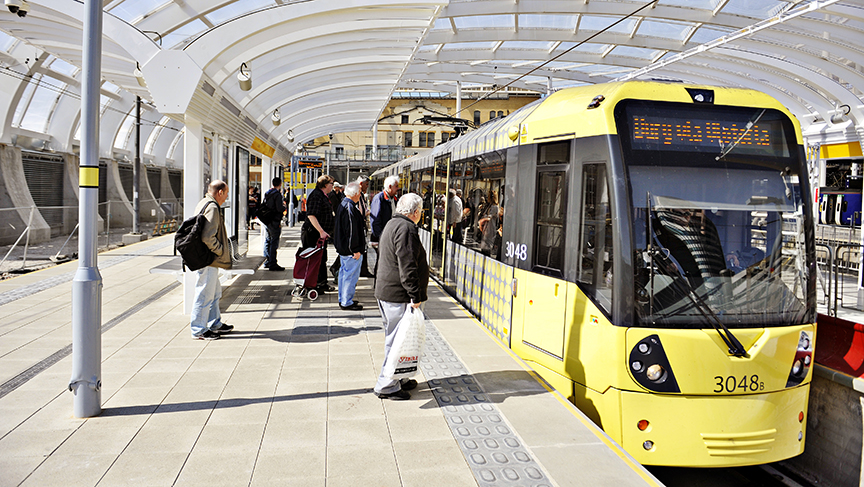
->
left=534, top=171, right=567, bottom=277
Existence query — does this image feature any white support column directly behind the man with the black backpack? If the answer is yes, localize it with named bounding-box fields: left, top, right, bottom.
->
left=183, top=115, right=203, bottom=315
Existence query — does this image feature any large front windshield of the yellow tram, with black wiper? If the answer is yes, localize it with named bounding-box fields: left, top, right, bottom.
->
left=625, top=103, right=810, bottom=328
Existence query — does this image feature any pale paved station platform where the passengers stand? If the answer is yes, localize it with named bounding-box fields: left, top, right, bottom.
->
left=0, top=227, right=661, bottom=487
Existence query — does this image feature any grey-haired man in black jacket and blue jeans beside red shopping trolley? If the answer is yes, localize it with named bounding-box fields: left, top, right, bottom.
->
left=333, top=183, right=366, bottom=311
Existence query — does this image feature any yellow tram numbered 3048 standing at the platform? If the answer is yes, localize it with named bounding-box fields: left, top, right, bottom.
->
left=373, top=81, right=816, bottom=467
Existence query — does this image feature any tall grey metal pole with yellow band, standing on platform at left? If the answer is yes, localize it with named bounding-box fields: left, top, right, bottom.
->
left=69, top=0, right=102, bottom=418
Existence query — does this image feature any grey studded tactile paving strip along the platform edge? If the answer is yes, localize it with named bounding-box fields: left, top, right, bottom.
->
left=420, top=321, right=552, bottom=487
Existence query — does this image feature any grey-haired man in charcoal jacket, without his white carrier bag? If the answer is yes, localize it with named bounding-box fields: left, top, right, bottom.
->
left=375, top=193, right=429, bottom=400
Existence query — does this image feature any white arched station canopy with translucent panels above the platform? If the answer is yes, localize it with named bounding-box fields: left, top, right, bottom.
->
left=0, top=0, right=864, bottom=166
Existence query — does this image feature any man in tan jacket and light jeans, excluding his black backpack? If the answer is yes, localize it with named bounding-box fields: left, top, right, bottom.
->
left=191, top=179, right=234, bottom=340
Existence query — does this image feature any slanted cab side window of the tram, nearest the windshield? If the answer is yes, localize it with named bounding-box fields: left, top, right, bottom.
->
left=578, top=164, right=614, bottom=311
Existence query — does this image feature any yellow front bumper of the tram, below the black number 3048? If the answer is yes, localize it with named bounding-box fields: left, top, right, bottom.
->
left=620, top=383, right=810, bottom=467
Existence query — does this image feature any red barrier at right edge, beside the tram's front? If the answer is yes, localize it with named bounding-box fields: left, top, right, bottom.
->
left=815, top=314, right=864, bottom=377
